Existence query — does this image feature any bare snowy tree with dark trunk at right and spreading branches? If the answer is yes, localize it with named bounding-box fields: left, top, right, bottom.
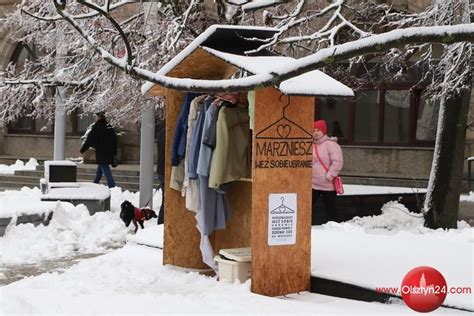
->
left=0, top=0, right=474, bottom=228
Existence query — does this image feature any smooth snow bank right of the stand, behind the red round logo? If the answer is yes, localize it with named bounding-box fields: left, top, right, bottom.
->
left=311, top=201, right=474, bottom=311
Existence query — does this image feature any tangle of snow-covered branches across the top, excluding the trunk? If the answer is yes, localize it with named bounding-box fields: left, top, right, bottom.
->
left=0, top=0, right=474, bottom=120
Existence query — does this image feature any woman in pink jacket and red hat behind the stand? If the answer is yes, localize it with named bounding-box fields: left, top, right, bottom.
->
left=313, top=120, right=343, bottom=224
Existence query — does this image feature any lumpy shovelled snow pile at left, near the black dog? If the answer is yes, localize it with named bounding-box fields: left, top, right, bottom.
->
left=0, top=202, right=128, bottom=265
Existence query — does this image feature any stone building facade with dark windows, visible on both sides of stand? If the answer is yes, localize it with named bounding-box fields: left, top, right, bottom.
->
left=0, top=0, right=474, bottom=187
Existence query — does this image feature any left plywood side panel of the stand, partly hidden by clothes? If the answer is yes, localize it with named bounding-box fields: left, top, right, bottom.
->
left=163, top=90, right=209, bottom=269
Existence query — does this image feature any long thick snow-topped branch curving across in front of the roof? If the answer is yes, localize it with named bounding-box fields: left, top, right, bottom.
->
left=51, top=1, right=474, bottom=92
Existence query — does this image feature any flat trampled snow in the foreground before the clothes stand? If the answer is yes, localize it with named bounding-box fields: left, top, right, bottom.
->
left=0, top=245, right=468, bottom=315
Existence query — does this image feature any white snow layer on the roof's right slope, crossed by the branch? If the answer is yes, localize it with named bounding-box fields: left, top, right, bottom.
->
left=201, top=47, right=354, bottom=97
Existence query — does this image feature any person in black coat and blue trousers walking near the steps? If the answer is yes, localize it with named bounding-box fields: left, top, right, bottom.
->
left=80, top=112, right=117, bottom=188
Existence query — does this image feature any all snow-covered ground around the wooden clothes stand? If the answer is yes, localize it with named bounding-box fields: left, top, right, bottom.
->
left=0, top=188, right=474, bottom=315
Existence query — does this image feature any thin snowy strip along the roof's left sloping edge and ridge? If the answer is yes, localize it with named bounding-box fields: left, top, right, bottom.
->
left=141, top=24, right=278, bottom=94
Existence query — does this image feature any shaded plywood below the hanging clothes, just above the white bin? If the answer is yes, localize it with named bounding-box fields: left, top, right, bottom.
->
left=214, top=181, right=252, bottom=253
